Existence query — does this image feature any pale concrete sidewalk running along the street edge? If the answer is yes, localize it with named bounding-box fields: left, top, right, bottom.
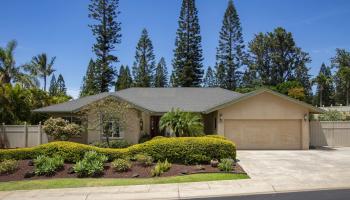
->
left=0, top=177, right=350, bottom=200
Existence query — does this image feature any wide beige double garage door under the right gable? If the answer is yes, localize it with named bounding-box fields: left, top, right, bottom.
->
left=224, top=120, right=301, bottom=149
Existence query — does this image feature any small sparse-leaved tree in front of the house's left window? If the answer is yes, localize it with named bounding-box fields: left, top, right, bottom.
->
left=79, top=96, right=130, bottom=147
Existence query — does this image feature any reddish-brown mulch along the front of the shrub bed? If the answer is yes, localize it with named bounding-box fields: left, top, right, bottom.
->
left=0, top=160, right=245, bottom=182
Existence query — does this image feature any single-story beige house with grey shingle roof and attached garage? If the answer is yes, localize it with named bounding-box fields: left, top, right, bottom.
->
left=34, top=88, right=323, bottom=149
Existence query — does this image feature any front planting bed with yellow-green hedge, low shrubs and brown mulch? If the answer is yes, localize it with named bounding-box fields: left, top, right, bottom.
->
left=0, top=136, right=245, bottom=181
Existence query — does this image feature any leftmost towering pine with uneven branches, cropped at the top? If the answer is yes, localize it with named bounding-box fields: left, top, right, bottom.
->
left=89, top=0, right=121, bottom=92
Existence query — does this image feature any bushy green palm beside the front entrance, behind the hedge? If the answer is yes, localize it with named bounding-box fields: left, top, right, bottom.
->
left=159, top=109, right=204, bottom=137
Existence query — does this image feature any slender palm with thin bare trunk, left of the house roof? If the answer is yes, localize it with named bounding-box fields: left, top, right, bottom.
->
left=27, top=53, right=56, bottom=91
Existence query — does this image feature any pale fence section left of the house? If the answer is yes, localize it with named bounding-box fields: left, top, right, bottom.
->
left=0, top=124, right=48, bottom=148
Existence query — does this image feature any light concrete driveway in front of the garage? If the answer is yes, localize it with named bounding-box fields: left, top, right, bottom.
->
left=238, top=148, right=350, bottom=187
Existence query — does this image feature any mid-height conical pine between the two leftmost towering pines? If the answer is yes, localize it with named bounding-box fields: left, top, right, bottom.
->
left=132, top=29, right=155, bottom=87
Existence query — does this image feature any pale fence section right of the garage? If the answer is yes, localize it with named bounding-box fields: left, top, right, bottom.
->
left=310, top=121, right=350, bottom=147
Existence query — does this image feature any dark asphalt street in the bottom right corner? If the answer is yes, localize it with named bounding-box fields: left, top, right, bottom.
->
left=196, top=189, right=350, bottom=200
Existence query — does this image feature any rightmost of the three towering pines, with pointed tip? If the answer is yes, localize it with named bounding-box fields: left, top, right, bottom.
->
left=216, top=0, right=244, bottom=90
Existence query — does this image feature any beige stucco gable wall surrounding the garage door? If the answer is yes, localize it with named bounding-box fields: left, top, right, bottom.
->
left=217, top=92, right=309, bottom=149
